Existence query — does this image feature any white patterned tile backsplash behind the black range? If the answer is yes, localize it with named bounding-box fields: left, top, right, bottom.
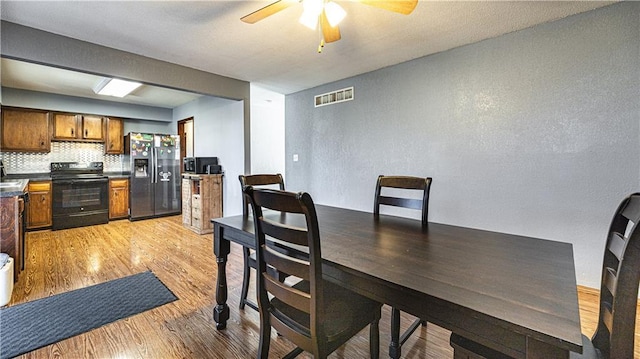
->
left=0, top=141, right=128, bottom=174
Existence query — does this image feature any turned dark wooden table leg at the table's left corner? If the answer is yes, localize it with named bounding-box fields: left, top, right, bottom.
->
left=213, top=224, right=231, bottom=330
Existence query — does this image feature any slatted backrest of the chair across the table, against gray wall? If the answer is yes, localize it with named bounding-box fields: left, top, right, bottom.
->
left=373, top=175, right=432, bottom=227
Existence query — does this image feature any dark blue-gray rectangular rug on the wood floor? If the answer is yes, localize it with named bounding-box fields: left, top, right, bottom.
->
left=0, top=272, right=178, bottom=359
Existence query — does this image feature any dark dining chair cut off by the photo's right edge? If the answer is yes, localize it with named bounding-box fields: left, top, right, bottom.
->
left=450, top=193, right=640, bottom=359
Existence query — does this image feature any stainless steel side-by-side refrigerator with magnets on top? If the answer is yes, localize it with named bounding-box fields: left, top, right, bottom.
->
left=125, top=132, right=182, bottom=220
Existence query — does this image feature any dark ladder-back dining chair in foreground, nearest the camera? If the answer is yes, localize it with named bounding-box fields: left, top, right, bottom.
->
left=243, top=186, right=382, bottom=358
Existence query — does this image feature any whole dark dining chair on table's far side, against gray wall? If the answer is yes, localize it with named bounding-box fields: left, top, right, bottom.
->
left=373, top=175, right=432, bottom=359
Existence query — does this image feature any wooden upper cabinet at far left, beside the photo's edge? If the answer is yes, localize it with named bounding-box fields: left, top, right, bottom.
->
left=0, top=107, right=51, bottom=152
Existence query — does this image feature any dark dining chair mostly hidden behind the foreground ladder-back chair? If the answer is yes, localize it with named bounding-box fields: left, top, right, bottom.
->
left=238, top=173, right=284, bottom=310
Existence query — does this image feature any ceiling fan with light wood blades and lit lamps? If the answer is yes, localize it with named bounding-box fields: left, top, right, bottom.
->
left=240, top=0, right=418, bottom=52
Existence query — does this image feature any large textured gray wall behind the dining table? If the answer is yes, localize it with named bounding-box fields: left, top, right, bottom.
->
left=286, top=3, right=640, bottom=287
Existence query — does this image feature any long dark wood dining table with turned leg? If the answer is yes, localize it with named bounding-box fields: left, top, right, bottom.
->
left=212, top=205, right=582, bottom=359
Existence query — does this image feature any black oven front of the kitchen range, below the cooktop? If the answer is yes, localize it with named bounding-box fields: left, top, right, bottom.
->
left=52, top=177, right=109, bottom=230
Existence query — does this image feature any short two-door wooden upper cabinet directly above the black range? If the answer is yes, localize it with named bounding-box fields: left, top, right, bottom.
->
left=53, top=112, right=104, bottom=142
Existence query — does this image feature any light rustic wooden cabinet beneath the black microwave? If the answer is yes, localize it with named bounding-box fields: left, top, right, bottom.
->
left=182, top=174, right=223, bottom=234
